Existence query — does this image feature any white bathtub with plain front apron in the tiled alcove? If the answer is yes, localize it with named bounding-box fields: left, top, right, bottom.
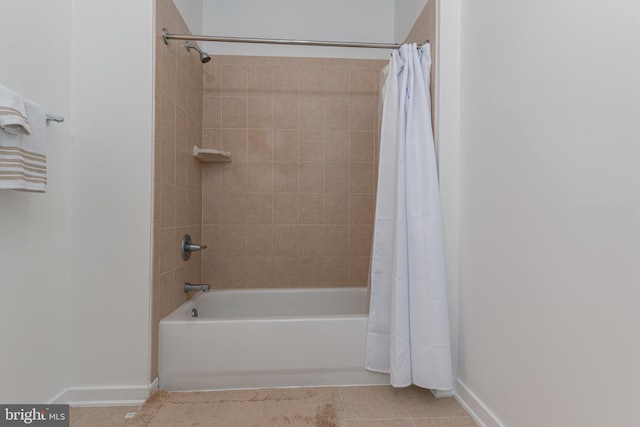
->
left=158, top=288, right=389, bottom=390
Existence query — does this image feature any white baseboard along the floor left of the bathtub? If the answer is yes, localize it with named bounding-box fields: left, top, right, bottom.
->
left=49, top=377, right=158, bottom=406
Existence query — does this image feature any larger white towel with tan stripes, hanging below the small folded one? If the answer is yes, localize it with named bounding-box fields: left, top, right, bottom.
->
left=0, top=99, right=47, bottom=193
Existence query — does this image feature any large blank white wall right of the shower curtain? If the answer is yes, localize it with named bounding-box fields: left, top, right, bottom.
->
left=452, top=0, right=640, bottom=427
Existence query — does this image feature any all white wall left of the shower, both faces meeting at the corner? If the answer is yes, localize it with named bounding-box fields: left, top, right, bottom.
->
left=0, top=0, right=154, bottom=403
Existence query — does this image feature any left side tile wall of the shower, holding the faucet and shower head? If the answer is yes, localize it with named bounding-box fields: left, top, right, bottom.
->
left=151, top=0, right=202, bottom=379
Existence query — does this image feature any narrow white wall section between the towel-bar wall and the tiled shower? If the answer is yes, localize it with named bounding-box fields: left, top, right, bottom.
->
left=70, top=0, right=154, bottom=400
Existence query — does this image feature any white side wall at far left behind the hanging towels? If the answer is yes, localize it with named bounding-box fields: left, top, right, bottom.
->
left=0, top=0, right=71, bottom=403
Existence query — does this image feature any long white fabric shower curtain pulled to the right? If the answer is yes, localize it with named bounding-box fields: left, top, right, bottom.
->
left=365, top=44, right=453, bottom=390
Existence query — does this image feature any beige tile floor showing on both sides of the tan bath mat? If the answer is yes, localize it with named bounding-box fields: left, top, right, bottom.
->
left=70, top=386, right=477, bottom=427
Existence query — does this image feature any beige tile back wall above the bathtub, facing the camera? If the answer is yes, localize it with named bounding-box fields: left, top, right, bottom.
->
left=202, top=56, right=387, bottom=288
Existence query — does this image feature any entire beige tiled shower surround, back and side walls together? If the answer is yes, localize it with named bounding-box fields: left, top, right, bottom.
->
left=150, top=0, right=437, bottom=380
